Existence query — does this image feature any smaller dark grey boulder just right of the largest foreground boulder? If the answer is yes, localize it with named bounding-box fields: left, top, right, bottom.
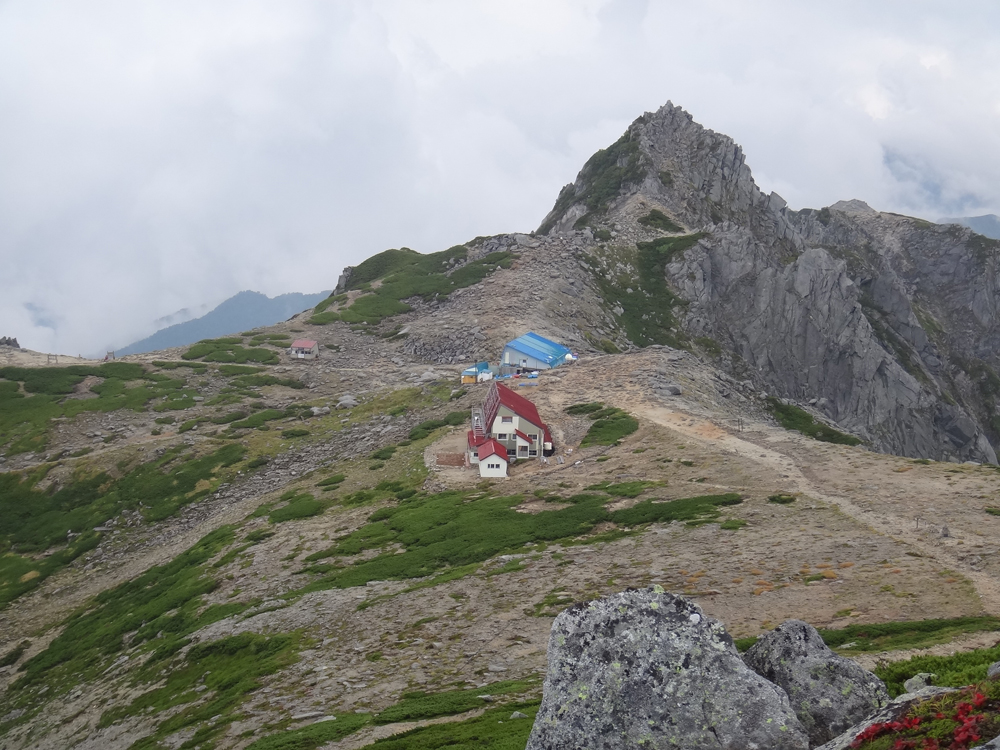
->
left=743, top=620, right=889, bottom=747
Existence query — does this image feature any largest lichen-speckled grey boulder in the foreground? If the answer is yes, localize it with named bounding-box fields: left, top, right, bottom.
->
left=527, top=586, right=808, bottom=750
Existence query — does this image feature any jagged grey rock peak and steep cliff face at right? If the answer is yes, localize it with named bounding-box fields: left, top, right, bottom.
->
left=544, top=103, right=1000, bottom=463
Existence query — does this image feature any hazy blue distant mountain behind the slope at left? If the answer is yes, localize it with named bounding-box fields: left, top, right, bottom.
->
left=115, top=291, right=330, bottom=355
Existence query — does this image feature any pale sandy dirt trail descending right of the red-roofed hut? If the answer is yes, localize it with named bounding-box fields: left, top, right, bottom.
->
left=618, top=401, right=1000, bottom=614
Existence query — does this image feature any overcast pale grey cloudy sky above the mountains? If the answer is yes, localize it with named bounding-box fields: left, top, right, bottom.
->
left=0, top=0, right=1000, bottom=355
